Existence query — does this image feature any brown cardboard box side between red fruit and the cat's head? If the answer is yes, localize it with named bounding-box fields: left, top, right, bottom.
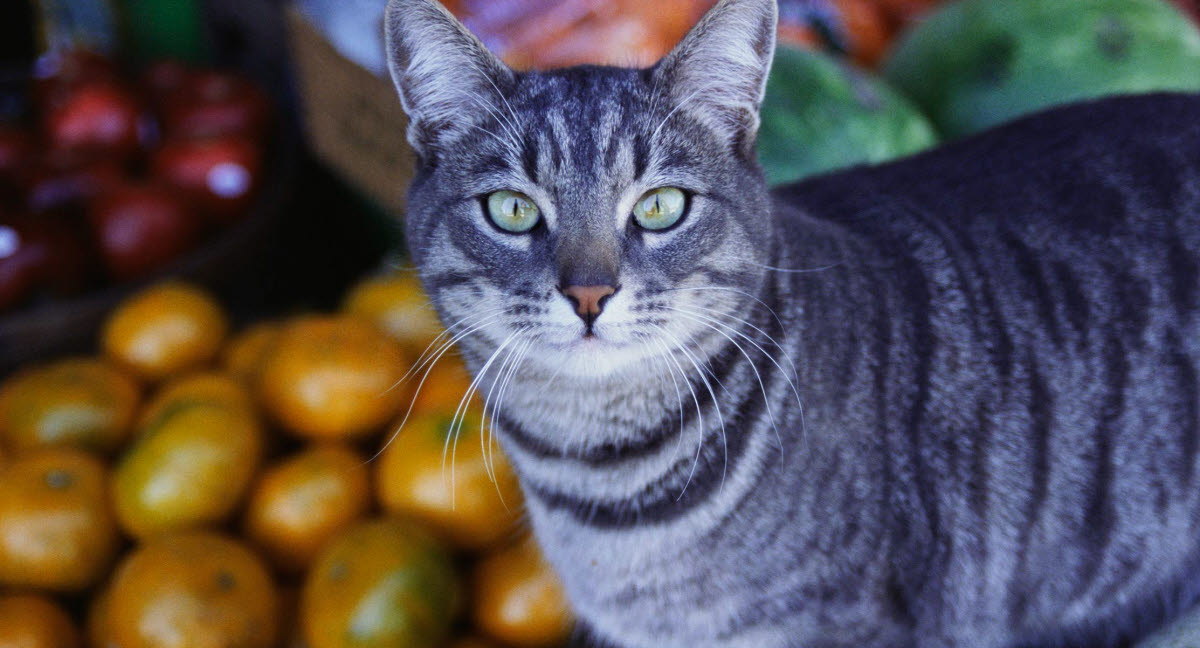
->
left=286, top=7, right=414, bottom=216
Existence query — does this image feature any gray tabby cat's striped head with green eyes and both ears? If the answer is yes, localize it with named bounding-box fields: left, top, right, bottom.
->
left=386, top=0, right=776, bottom=377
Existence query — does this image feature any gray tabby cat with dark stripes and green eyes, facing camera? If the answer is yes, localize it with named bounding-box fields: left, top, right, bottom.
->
left=386, top=0, right=1200, bottom=648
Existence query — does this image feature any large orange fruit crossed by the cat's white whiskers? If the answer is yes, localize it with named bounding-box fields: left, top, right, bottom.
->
left=376, top=410, right=523, bottom=550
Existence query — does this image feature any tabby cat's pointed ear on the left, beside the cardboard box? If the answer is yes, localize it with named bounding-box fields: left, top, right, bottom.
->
left=384, top=0, right=512, bottom=160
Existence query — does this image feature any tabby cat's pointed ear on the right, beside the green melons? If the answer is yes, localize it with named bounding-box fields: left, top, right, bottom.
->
left=654, top=0, right=779, bottom=157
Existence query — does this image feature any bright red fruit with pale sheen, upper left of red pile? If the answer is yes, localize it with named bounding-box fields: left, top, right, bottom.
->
left=44, top=80, right=142, bottom=158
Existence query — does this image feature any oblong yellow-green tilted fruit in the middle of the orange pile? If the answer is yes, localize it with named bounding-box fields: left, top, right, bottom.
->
left=113, top=401, right=263, bottom=538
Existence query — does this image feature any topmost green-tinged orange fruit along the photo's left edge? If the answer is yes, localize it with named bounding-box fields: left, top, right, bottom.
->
left=0, top=358, right=138, bottom=452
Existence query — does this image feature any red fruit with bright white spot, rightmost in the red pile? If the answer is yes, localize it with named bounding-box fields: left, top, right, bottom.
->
left=151, top=136, right=263, bottom=223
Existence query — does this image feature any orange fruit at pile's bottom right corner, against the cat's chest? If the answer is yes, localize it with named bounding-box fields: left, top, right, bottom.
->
left=470, top=535, right=575, bottom=648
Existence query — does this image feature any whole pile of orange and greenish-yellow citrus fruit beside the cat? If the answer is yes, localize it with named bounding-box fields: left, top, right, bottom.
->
left=0, top=271, right=572, bottom=648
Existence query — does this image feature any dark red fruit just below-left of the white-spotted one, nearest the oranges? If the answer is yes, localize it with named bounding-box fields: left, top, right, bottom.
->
left=88, top=185, right=198, bottom=280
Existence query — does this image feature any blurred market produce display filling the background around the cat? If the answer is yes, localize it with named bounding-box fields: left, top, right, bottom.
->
left=0, top=0, right=1200, bottom=648
